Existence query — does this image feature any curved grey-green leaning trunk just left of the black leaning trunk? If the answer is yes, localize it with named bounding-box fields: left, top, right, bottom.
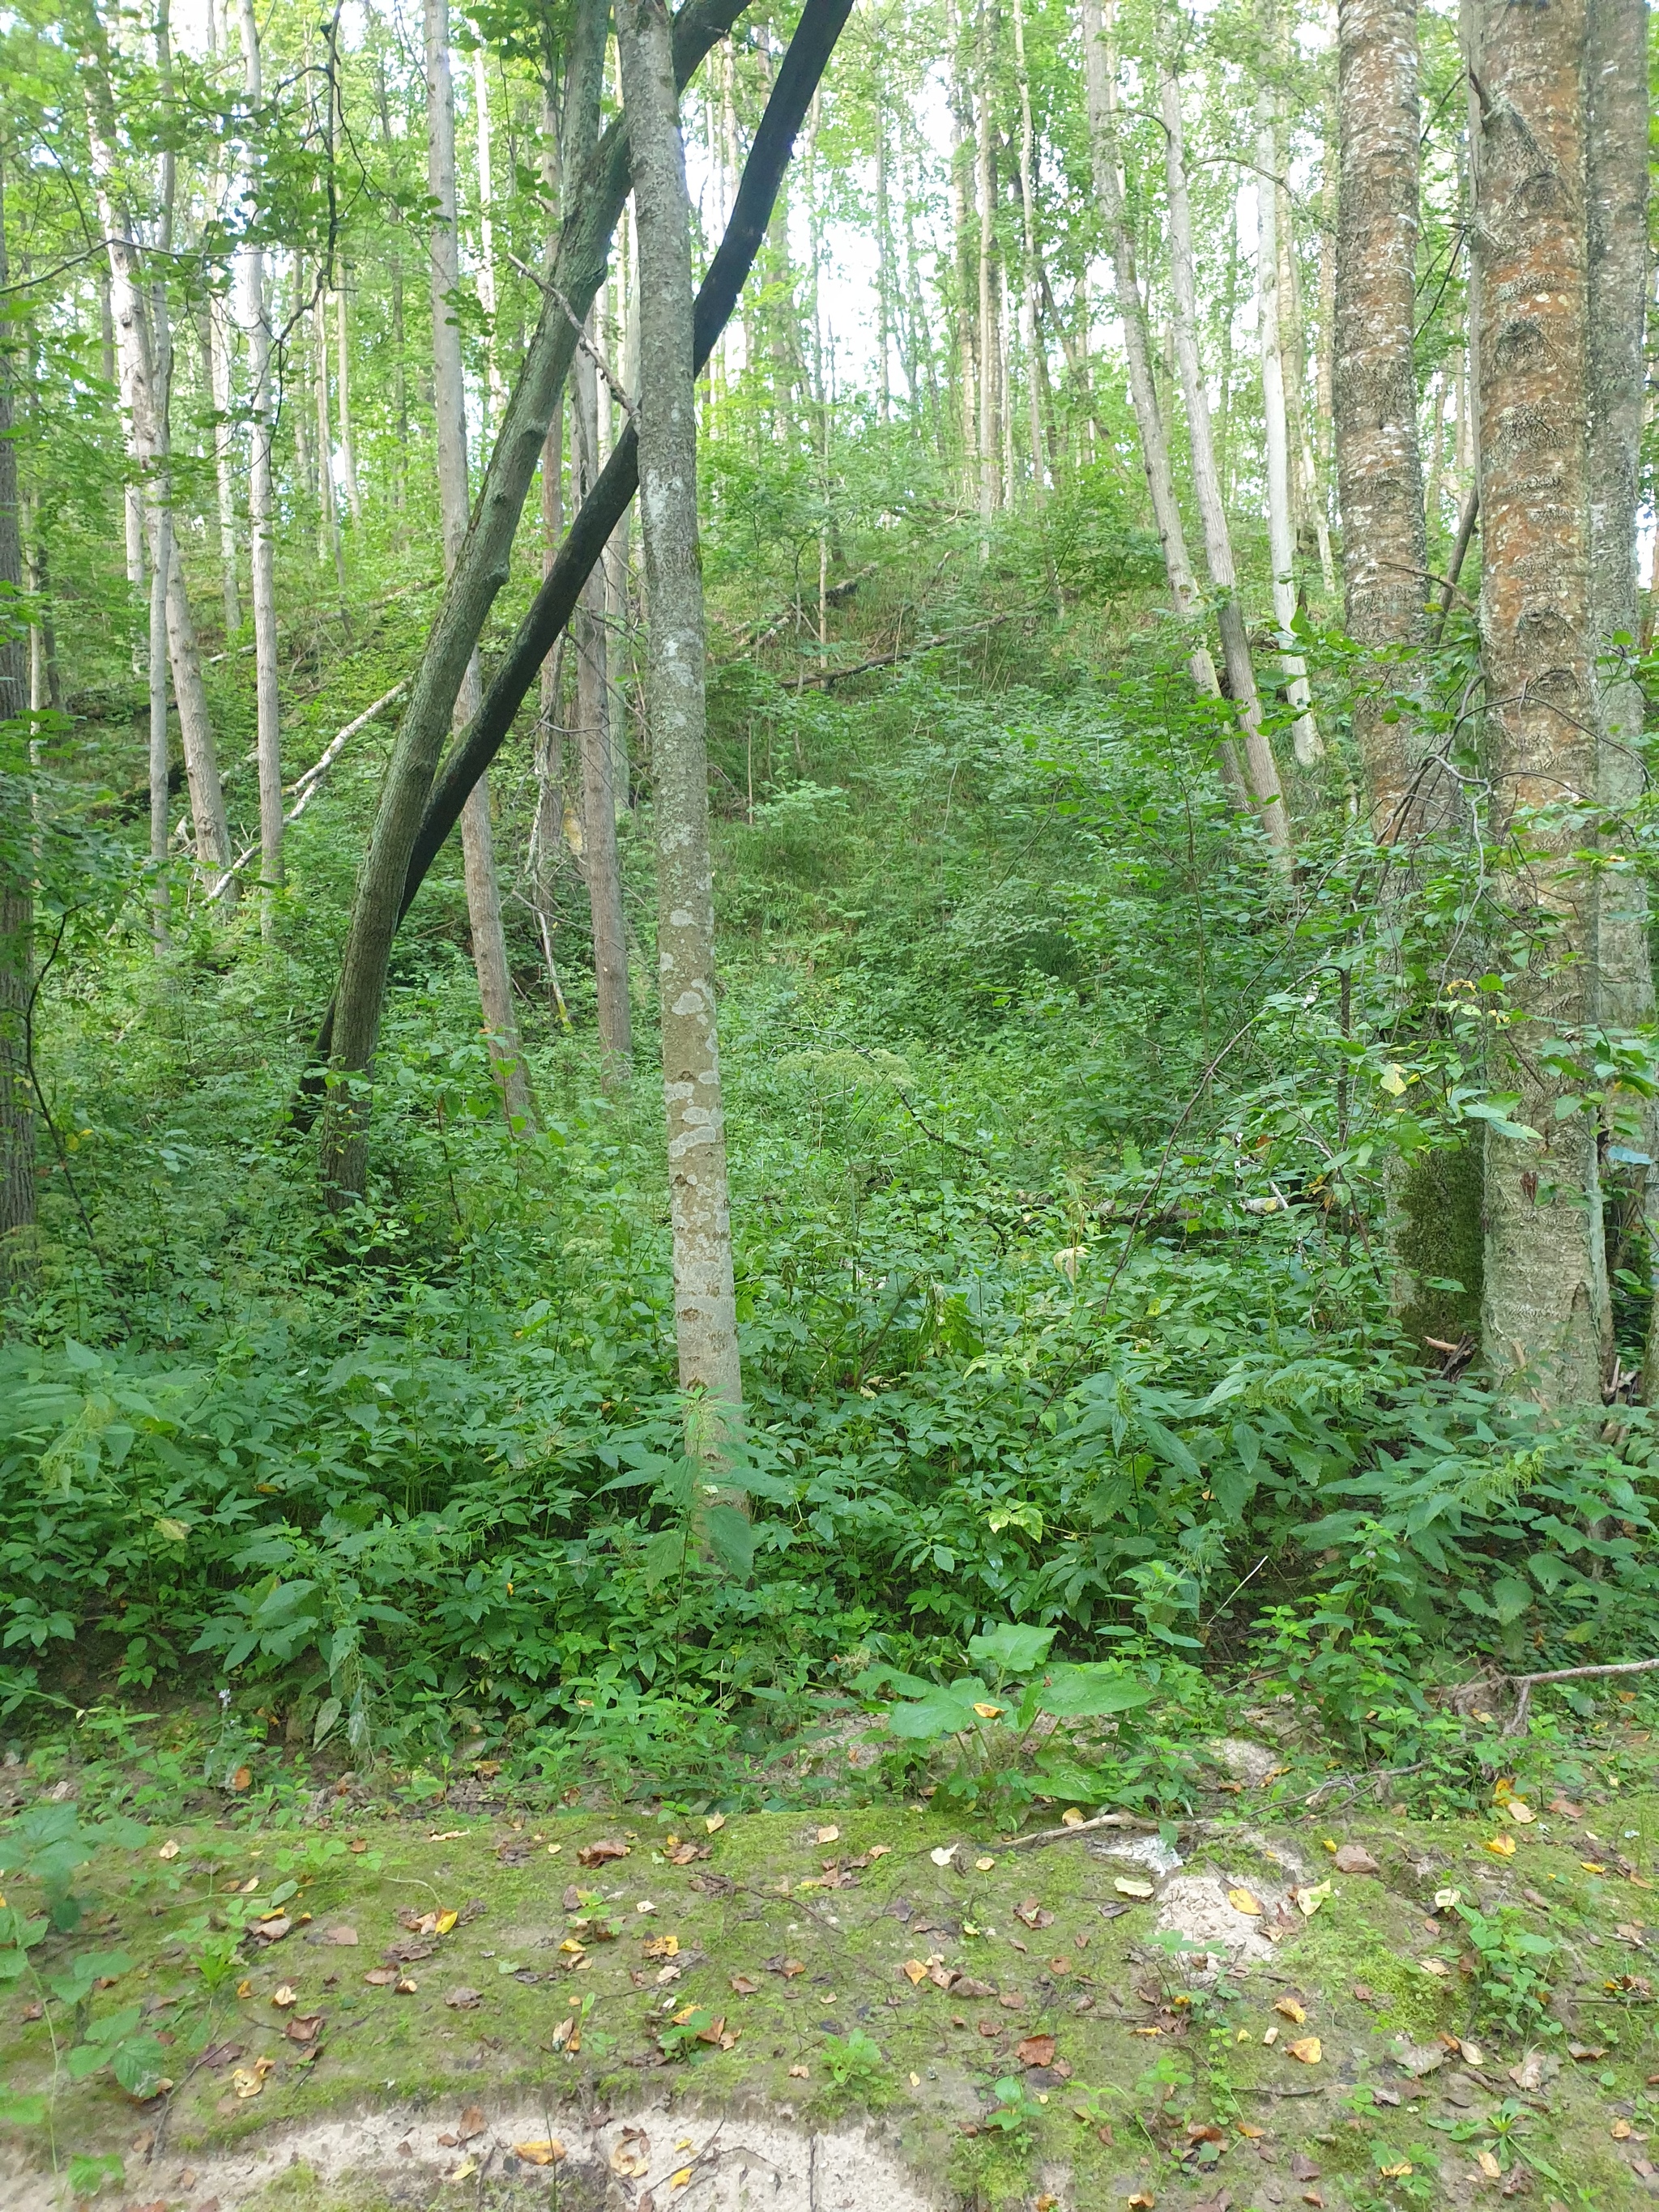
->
left=318, top=0, right=744, bottom=1196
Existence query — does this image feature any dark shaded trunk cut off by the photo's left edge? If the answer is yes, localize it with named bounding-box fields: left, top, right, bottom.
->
left=0, top=175, right=36, bottom=1285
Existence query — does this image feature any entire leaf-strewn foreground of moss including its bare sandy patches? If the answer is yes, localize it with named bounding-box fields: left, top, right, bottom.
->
left=0, top=1737, right=1659, bottom=2212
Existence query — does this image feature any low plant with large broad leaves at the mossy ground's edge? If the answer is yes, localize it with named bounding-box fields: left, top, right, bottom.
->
left=854, top=1622, right=1163, bottom=1813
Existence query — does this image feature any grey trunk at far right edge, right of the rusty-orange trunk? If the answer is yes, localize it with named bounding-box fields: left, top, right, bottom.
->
left=1584, top=0, right=1659, bottom=1404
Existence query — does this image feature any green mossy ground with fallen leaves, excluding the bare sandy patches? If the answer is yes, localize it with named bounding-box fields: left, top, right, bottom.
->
left=0, top=1792, right=1659, bottom=2212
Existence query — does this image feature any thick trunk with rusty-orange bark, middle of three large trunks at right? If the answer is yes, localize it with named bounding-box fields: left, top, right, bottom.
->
left=1478, top=0, right=1610, bottom=1404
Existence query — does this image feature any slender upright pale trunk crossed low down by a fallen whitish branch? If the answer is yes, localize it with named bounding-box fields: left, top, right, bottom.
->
left=237, top=0, right=284, bottom=938
